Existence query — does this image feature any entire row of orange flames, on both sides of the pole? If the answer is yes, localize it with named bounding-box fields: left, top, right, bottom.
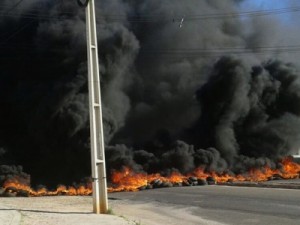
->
left=3, top=157, right=300, bottom=196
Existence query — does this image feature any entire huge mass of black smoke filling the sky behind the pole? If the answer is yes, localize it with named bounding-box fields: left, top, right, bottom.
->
left=0, top=0, right=300, bottom=184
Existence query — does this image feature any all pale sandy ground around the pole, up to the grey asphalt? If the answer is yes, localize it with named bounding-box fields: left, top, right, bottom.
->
left=0, top=196, right=223, bottom=225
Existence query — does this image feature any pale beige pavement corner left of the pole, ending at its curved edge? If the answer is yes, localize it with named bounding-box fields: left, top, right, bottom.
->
left=0, top=196, right=134, bottom=225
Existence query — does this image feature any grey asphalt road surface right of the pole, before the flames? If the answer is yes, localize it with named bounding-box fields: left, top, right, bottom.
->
left=110, top=186, right=300, bottom=225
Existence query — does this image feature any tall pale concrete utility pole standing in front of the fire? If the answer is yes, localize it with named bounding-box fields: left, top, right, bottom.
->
left=77, top=0, right=108, bottom=214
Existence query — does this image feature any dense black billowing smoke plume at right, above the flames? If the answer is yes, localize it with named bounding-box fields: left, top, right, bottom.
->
left=193, top=57, right=300, bottom=164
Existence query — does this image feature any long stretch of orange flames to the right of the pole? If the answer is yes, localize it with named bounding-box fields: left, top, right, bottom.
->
left=109, top=157, right=300, bottom=192
